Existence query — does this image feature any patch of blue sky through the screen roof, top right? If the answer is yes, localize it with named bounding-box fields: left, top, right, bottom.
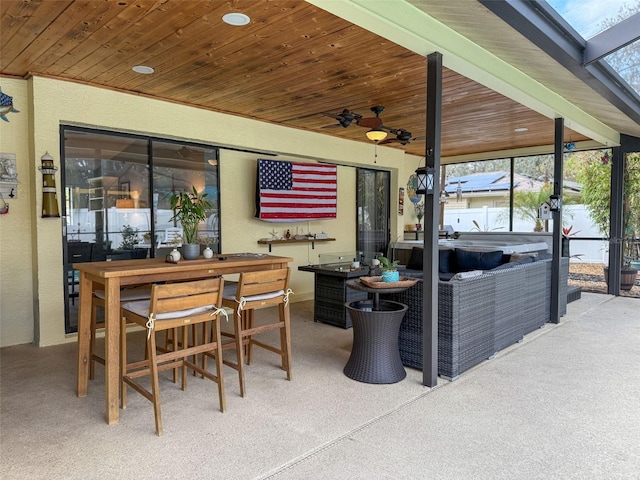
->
left=547, top=0, right=634, bottom=39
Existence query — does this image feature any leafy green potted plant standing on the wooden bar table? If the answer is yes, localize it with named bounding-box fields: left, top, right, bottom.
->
left=170, top=186, right=212, bottom=260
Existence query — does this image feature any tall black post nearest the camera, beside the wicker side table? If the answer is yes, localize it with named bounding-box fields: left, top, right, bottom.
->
left=422, top=52, right=442, bottom=387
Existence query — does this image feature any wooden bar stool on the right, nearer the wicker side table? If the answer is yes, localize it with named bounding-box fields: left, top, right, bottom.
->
left=222, top=268, right=293, bottom=397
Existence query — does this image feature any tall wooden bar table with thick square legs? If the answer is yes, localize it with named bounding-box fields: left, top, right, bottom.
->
left=73, top=253, right=293, bottom=425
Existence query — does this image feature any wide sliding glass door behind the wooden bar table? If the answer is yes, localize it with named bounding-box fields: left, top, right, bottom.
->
left=61, top=126, right=220, bottom=333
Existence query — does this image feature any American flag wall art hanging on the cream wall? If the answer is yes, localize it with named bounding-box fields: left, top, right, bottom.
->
left=256, top=159, right=338, bottom=222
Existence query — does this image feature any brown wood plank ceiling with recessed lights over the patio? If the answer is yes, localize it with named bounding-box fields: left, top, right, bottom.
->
left=0, top=0, right=586, bottom=161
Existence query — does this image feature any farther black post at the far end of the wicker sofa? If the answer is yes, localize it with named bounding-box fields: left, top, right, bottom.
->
left=550, top=118, right=564, bottom=323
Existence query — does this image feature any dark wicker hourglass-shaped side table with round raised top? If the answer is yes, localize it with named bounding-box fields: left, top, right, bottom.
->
left=344, top=279, right=408, bottom=384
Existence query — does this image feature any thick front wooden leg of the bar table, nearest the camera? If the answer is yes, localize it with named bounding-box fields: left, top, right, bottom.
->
left=105, top=277, right=120, bottom=425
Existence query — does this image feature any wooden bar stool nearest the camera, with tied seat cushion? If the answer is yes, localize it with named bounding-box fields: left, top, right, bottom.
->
left=120, top=278, right=226, bottom=436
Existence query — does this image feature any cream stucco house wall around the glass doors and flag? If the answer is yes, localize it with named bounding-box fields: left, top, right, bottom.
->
left=0, top=77, right=418, bottom=346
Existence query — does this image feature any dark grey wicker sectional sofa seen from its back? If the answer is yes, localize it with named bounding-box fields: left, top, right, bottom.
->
left=385, top=249, right=569, bottom=380
